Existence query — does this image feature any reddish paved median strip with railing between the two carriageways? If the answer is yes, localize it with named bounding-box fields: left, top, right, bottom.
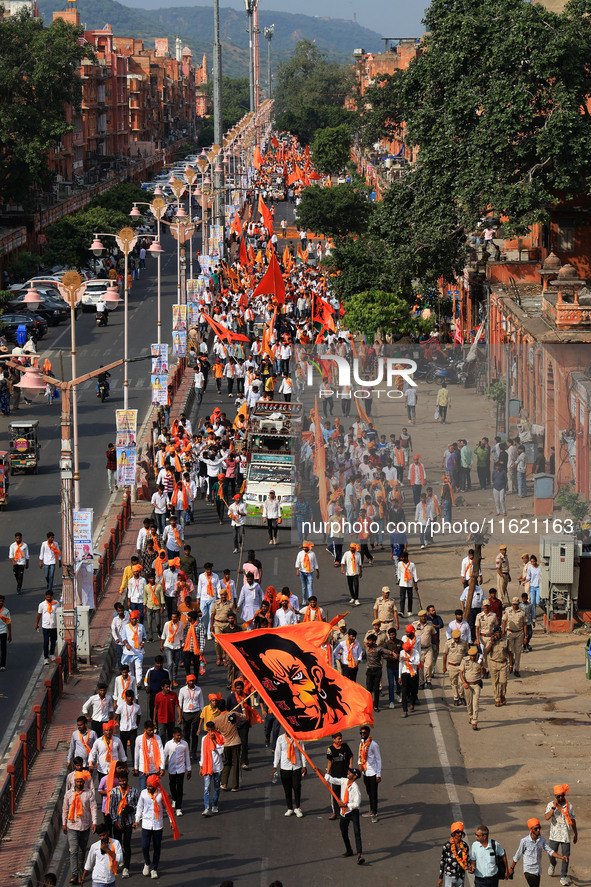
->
left=0, top=369, right=193, bottom=887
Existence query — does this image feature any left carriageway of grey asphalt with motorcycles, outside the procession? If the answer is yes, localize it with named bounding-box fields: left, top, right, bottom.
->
left=0, top=227, right=187, bottom=736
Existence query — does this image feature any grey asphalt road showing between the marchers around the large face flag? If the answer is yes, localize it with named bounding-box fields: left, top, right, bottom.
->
left=48, top=370, right=478, bottom=887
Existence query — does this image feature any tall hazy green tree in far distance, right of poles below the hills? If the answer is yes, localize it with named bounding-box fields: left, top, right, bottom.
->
left=274, top=40, right=356, bottom=144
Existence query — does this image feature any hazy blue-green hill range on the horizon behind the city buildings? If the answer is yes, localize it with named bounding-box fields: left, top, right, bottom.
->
left=37, top=0, right=383, bottom=76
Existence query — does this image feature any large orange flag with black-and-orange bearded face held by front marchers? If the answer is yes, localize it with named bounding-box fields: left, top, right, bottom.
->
left=215, top=622, right=373, bottom=740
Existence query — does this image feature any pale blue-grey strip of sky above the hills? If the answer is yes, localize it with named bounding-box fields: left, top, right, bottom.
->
left=120, top=0, right=426, bottom=37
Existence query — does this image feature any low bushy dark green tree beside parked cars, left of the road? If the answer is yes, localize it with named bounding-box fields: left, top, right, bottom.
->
left=43, top=207, right=134, bottom=267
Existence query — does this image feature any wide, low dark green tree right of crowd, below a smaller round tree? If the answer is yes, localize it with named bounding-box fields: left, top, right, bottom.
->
left=298, top=185, right=374, bottom=237
